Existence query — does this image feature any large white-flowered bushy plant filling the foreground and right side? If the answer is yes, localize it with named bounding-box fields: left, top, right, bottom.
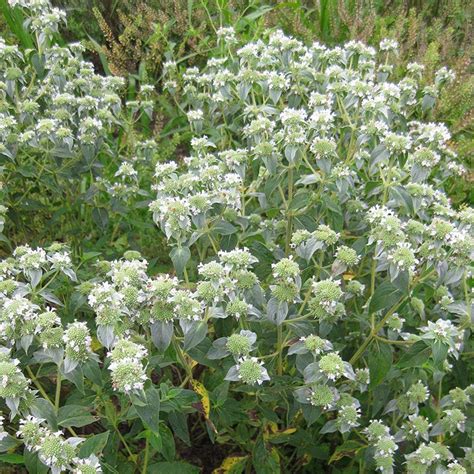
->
left=0, top=0, right=474, bottom=473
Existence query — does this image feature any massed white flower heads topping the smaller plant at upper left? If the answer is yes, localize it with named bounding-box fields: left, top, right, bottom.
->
left=0, top=20, right=123, bottom=159
